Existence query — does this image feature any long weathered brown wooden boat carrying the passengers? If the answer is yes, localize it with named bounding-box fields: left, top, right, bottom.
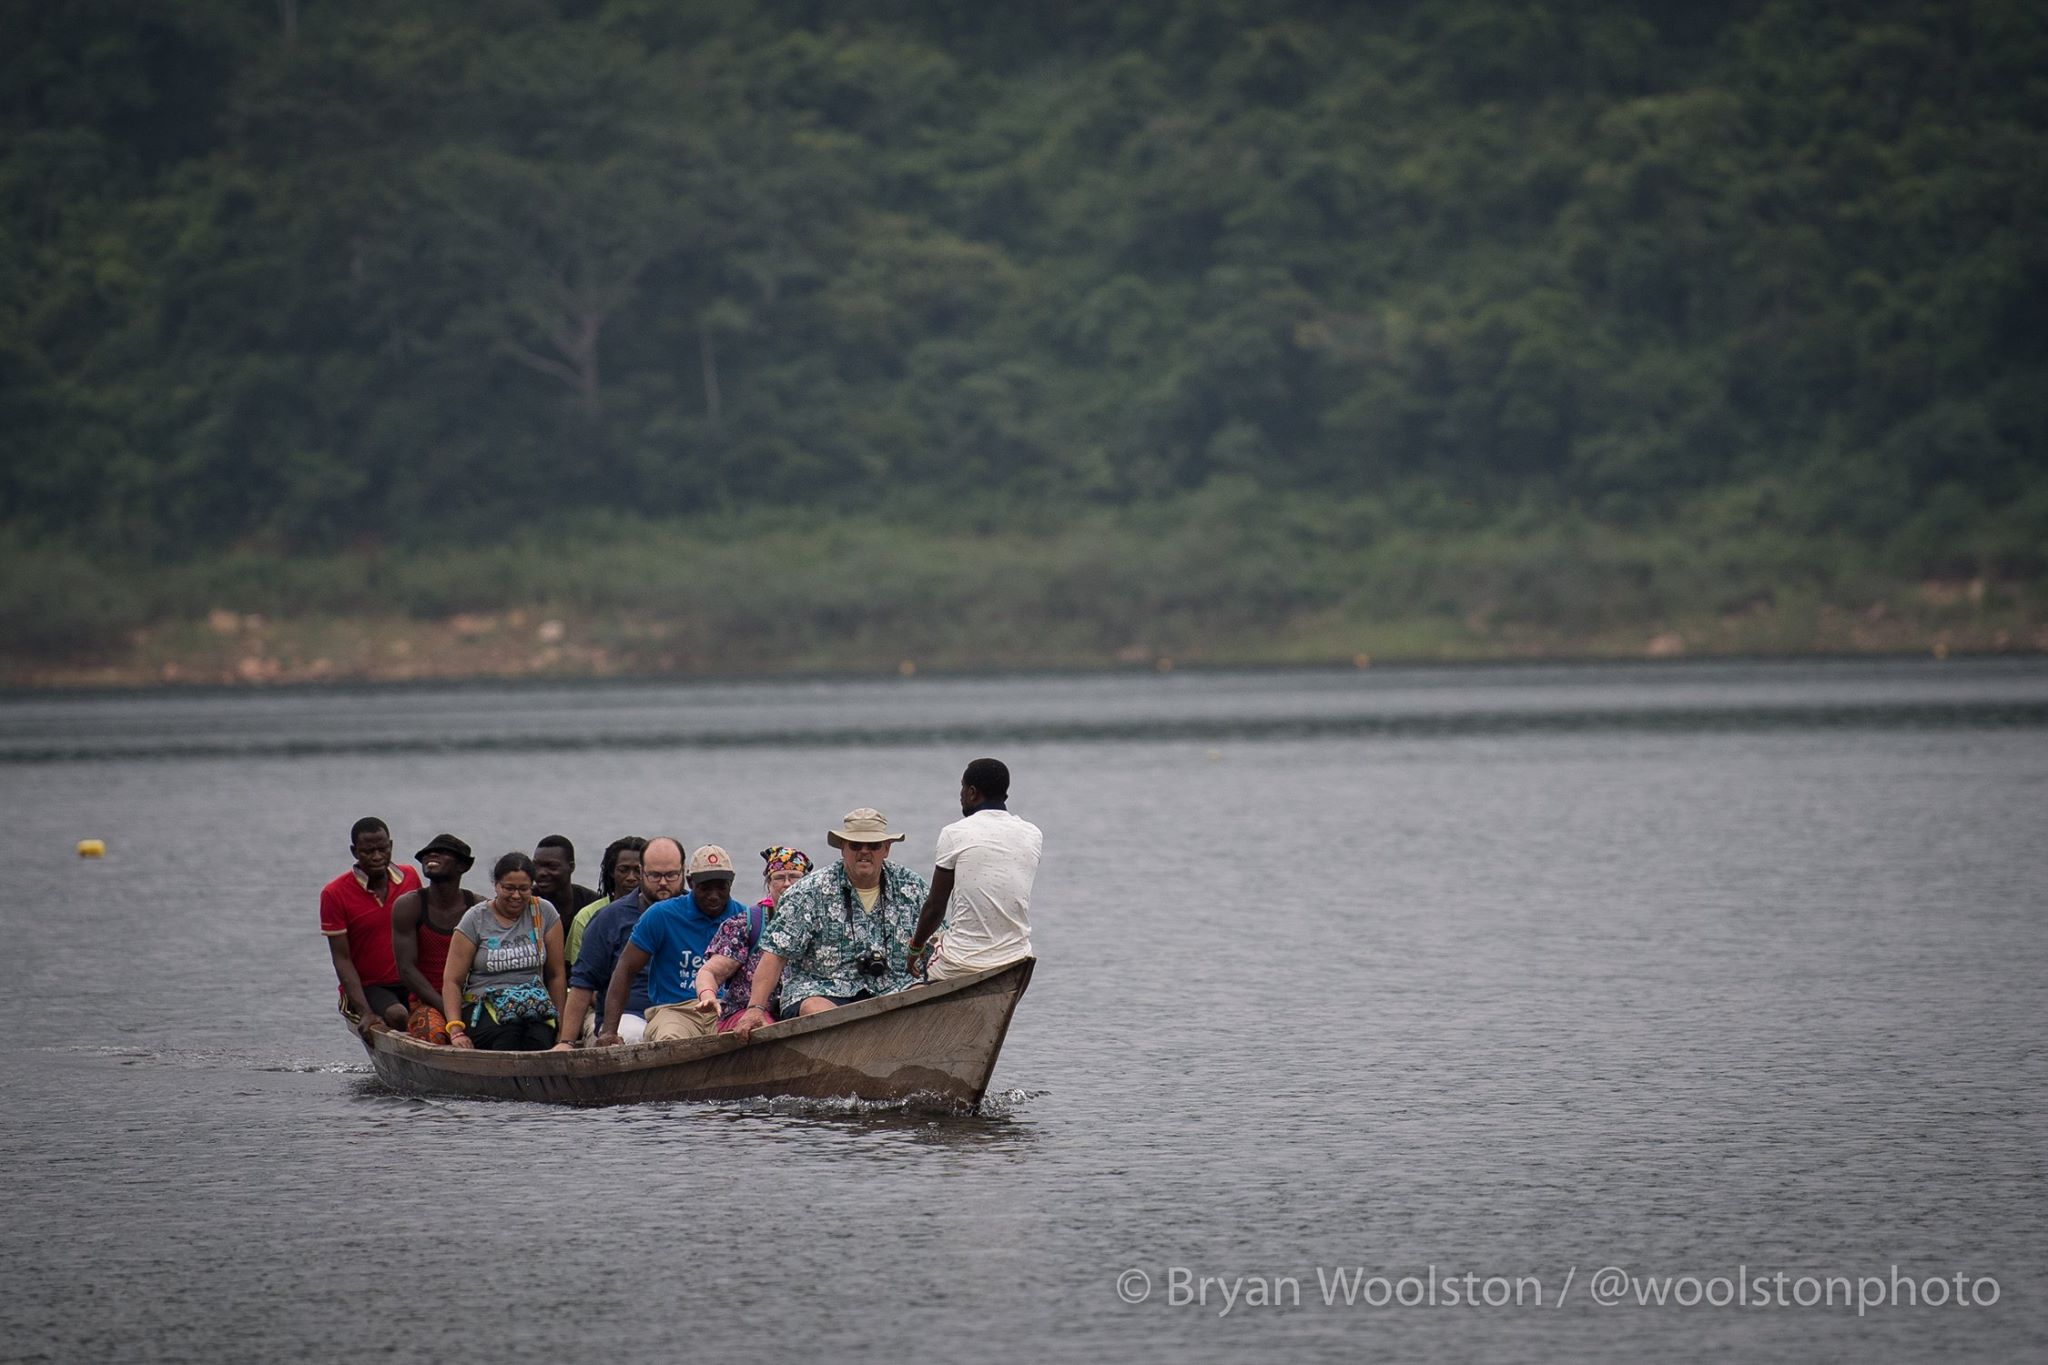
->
left=352, top=958, right=1034, bottom=1107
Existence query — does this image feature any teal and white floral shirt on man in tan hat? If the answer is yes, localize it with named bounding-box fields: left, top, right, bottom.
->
left=762, top=862, right=930, bottom=1015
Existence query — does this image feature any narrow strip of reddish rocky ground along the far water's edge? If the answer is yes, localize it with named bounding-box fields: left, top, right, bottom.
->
left=0, top=591, right=2048, bottom=690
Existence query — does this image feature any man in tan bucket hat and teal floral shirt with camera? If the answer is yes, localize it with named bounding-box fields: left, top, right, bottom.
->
left=733, top=806, right=930, bottom=1038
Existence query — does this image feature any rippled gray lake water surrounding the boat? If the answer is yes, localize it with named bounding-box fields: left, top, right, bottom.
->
left=0, top=661, right=2048, bottom=1361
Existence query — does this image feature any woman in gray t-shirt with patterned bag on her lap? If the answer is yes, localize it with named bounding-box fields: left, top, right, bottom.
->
left=440, top=853, right=569, bottom=1052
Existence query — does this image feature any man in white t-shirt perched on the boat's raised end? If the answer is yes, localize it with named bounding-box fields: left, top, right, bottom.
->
left=909, top=759, right=1044, bottom=980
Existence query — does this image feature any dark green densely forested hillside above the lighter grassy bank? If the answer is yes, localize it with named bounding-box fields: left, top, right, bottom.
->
left=0, top=0, right=2048, bottom=671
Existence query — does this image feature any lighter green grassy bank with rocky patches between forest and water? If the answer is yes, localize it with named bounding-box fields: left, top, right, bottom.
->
left=0, top=485, right=2048, bottom=688
